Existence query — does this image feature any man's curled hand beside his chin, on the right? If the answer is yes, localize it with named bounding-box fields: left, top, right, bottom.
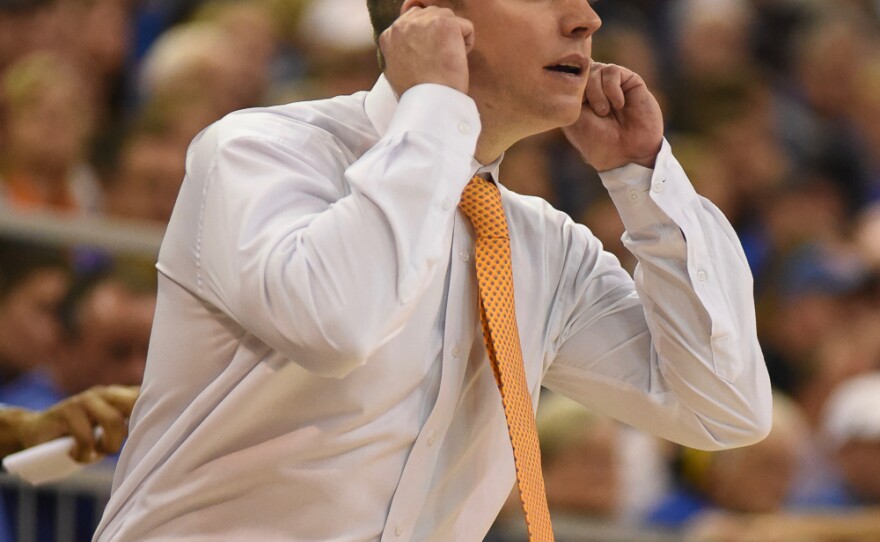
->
left=564, top=62, right=663, bottom=171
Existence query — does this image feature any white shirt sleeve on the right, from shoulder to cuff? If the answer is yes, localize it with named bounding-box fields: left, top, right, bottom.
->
left=544, top=141, right=771, bottom=449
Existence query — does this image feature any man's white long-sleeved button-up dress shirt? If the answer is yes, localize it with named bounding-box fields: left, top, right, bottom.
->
left=95, top=78, right=771, bottom=542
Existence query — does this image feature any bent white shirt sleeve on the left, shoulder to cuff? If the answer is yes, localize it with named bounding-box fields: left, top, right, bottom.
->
left=178, top=85, right=480, bottom=377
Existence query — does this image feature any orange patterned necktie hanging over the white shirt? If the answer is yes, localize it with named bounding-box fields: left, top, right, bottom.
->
left=459, top=177, right=553, bottom=542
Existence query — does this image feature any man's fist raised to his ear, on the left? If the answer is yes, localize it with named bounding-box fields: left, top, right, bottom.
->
left=379, top=0, right=474, bottom=96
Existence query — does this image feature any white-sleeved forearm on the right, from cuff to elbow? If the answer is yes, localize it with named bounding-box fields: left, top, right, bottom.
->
left=603, top=140, right=770, bottom=443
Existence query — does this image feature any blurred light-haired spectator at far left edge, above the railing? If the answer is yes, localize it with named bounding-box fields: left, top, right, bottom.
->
left=0, top=53, right=102, bottom=213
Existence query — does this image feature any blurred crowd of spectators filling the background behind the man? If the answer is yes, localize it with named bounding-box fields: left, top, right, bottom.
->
left=0, top=0, right=880, bottom=540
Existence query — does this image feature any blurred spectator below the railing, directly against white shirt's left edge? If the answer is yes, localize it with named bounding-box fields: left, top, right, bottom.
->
left=0, top=275, right=156, bottom=409
